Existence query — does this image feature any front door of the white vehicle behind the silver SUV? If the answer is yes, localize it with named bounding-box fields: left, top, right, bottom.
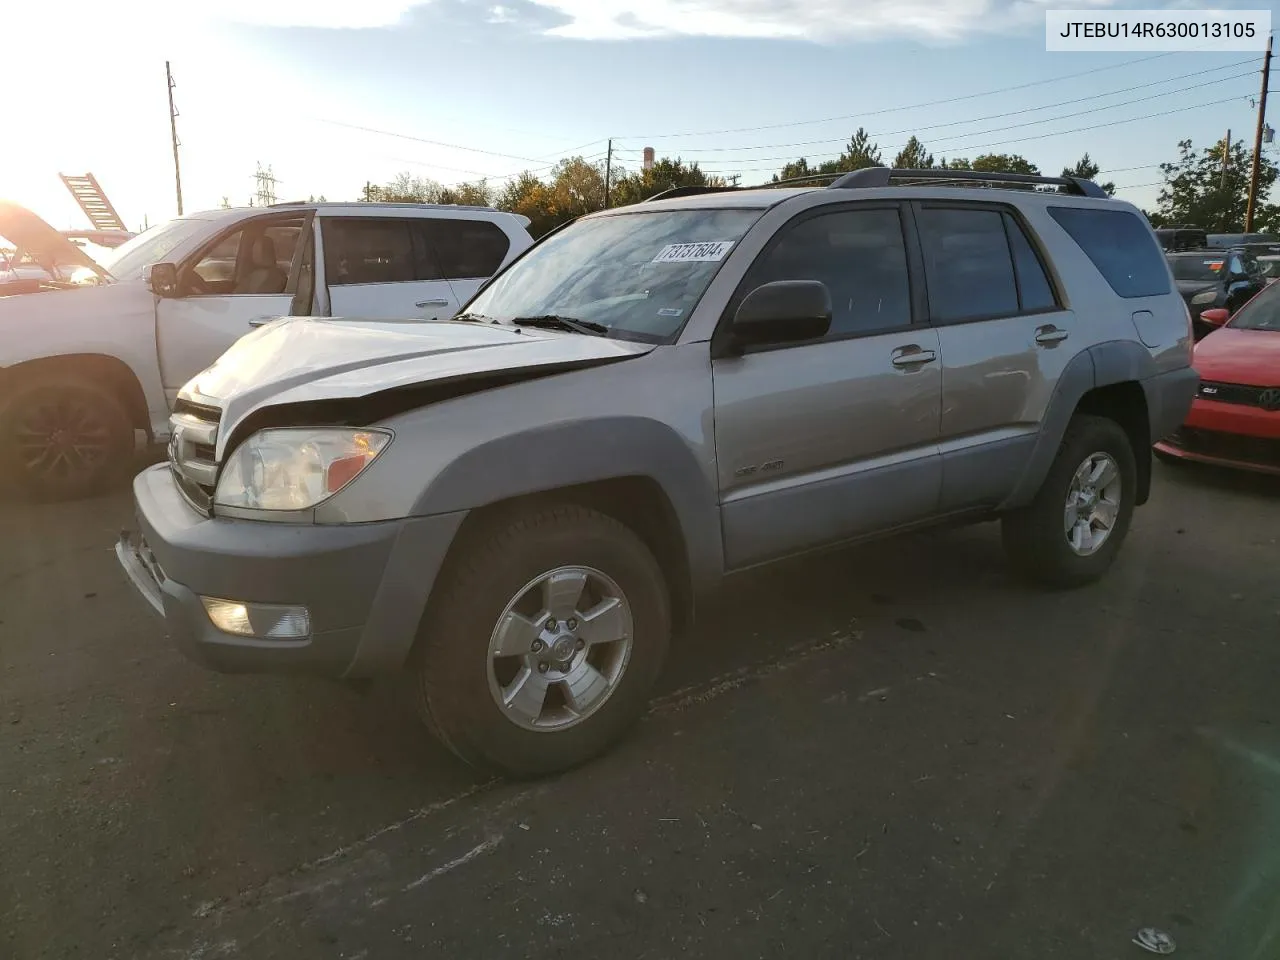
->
left=156, top=212, right=315, bottom=404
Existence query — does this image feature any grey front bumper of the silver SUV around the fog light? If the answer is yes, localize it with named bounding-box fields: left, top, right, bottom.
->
left=115, top=465, right=465, bottom=677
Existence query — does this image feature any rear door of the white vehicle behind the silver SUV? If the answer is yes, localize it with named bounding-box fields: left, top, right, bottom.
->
left=320, top=216, right=458, bottom=320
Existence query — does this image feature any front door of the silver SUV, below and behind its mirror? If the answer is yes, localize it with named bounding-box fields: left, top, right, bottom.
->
left=712, top=204, right=942, bottom=568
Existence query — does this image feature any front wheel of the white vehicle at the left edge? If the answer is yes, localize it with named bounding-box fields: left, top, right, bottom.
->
left=0, top=376, right=133, bottom=500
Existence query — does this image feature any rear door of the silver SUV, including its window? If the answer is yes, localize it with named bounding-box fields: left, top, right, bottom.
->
left=913, top=202, right=1079, bottom=513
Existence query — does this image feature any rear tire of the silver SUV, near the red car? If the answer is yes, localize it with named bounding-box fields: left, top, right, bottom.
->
left=1001, top=415, right=1138, bottom=589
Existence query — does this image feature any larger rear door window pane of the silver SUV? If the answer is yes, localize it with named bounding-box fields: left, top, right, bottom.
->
left=919, top=207, right=1018, bottom=323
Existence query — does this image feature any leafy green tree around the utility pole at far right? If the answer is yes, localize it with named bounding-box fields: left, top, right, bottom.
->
left=1156, top=140, right=1280, bottom=233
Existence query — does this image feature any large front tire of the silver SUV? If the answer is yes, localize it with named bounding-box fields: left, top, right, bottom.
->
left=412, top=504, right=672, bottom=778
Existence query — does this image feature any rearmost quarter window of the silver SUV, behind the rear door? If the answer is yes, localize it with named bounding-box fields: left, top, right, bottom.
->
left=1048, top=206, right=1169, bottom=298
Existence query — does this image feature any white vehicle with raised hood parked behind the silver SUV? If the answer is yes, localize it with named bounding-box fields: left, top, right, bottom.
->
left=0, top=204, right=532, bottom=499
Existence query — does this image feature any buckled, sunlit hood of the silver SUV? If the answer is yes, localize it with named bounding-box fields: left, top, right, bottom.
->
left=185, top=317, right=653, bottom=460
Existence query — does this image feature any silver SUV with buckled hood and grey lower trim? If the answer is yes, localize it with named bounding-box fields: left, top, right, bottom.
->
left=116, top=168, right=1198, bottom=776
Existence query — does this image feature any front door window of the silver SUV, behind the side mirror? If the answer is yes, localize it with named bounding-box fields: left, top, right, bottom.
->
left=737, top=207, right=911, bottom=338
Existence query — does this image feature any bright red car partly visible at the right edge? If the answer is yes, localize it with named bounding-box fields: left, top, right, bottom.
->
left=1156, top=283, right=1280, bottom=476
